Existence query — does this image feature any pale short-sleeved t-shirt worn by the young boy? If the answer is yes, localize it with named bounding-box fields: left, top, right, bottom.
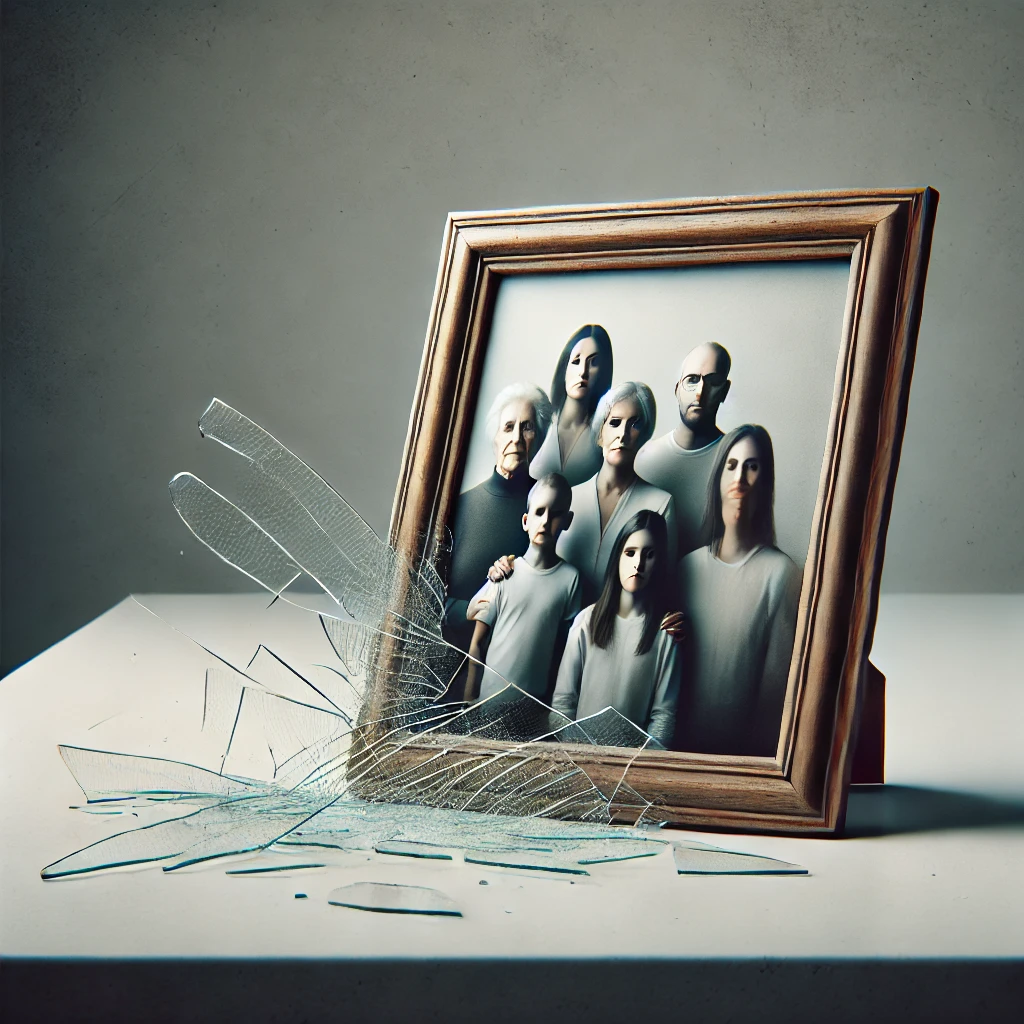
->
left=473, top=558, right=580, bottom=698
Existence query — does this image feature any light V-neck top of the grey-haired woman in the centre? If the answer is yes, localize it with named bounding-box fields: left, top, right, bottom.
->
left=557, top=475, right=676, bottom=601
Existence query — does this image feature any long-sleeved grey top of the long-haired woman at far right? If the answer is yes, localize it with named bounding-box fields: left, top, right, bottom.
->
left=678, top=547, right=801, bottom=756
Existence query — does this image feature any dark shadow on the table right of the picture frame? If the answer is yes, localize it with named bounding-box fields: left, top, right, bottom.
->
left=843, top=785, right=1024, bottom=839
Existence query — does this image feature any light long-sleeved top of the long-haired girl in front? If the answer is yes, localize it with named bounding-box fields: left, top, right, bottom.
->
left=551, top=604, right=680, bottom=746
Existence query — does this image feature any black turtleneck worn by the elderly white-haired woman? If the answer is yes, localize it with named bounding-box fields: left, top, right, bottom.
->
left=445, top=468, right=537, bottom=632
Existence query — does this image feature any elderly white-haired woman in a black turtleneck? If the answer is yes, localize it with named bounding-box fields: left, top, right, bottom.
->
left=444, top=382, right=551, bottom=650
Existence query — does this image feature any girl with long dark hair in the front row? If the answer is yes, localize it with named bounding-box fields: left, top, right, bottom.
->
left=551, top=509, right=680, bottom=746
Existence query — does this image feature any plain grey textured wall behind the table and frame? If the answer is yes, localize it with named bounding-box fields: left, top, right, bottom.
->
left=2, top=0, right=1024, bottom=668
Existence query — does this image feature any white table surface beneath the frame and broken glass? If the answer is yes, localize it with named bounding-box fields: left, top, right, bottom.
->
left=0, top=595, right=1024, bottom=1015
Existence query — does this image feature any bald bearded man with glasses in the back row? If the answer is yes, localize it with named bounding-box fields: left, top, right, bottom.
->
left=636, top=341, right=732, bottom=557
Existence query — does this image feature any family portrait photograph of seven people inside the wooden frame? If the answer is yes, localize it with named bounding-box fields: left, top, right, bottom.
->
left=445, top=259, right=850, bottom=756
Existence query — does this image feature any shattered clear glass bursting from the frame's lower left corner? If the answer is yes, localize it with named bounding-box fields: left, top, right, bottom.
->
left=42, top=399, right=794, bottom=880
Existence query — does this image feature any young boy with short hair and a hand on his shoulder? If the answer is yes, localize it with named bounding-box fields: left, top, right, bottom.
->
left=464, top=473, right=580, bottom=700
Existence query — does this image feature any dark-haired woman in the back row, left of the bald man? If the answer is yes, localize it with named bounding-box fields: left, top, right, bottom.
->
left=529, top=324, right=611, bottom=486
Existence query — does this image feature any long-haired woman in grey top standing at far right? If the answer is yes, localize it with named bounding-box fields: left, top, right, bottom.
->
left=674, top=424, right=800, bottom=757
